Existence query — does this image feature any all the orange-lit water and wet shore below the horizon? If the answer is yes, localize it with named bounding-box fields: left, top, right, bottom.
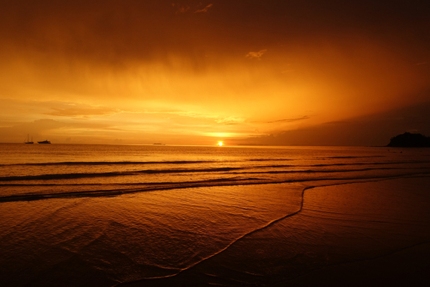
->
left=0, top=144, right=430, bottom=286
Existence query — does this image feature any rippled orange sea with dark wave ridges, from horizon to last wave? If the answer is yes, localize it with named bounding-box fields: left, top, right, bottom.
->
left=0, top=144, right=430, bottom=201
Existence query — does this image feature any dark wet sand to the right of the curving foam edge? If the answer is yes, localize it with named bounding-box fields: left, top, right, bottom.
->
left=126, top=177, right=430, bottom=286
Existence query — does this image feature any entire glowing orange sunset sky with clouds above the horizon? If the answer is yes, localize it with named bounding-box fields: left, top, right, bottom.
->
left=0, top=0, right=430, bottom=145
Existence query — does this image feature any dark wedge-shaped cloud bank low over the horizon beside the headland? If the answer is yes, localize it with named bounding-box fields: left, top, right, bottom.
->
left=253, top=102, right=430, bottom=146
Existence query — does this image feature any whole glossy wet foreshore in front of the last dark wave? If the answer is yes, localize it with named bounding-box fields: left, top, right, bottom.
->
left=0, top=177, right=430, bottom=286
